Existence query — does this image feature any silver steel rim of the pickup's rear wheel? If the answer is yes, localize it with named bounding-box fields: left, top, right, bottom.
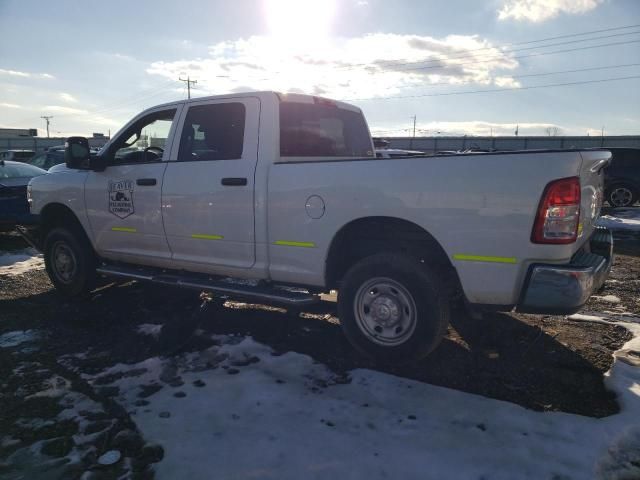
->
left=353, top=277, right=418, bottom=347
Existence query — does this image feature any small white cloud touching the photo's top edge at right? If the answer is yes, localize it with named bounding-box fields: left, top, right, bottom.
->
left=498, top=0, right=604, bottom=22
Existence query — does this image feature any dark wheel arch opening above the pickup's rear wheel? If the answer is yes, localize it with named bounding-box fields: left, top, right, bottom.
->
left=325, top=216, right=459, bottom=288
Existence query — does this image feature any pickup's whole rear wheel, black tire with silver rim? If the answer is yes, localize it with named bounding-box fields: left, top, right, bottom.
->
left=338, top=253, right=449, bottom=364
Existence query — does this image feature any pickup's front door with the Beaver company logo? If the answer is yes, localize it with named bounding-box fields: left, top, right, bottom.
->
left=85, top=106, right=180, bottom=265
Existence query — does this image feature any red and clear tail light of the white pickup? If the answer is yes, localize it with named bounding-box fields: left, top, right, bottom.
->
left=531, top=177, right=580, bottom=244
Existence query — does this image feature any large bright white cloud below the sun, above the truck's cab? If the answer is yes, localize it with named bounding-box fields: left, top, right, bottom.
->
left=147, top=33, right=518, bottom=99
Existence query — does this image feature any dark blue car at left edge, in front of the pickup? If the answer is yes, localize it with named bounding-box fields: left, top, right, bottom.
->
left=0, top=160, right=47, bottom=231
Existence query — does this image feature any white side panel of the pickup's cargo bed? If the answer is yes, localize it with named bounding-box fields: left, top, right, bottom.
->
left=267, top=152, right=584, bottom=305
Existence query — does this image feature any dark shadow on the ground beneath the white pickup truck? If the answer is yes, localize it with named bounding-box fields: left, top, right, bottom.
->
left=0, top=282, right=621, bottom=417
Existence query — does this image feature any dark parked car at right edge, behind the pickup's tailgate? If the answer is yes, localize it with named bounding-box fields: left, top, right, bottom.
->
left=604, top=148, right=640, bottom=207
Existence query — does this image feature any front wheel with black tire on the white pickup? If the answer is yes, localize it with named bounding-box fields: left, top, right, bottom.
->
left=44, top=227, right=97, bottom=298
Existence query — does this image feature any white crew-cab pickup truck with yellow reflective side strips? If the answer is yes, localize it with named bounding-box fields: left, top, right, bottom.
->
left=21, top=92, right=612, bottom=362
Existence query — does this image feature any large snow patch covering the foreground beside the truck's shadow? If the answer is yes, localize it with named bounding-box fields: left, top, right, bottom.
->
left=87, top=320, right=640, bottom=480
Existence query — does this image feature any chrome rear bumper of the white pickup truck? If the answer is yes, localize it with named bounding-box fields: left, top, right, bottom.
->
left=516, top=228, right=613, bottom=315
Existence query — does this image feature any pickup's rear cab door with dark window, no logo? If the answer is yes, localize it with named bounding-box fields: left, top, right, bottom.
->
left=162, top=97, right=260, bottom=271
